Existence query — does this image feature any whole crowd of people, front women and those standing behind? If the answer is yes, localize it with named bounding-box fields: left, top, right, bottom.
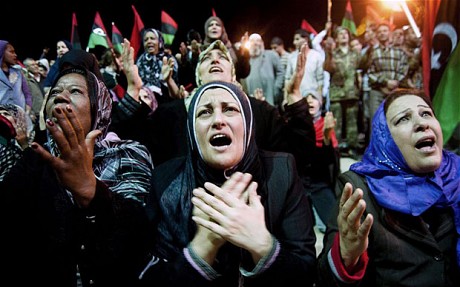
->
left=0, top=16, right=460, bottom=287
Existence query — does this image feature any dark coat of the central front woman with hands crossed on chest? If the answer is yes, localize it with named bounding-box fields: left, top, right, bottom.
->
left=139, top=152, right=316, bottom=287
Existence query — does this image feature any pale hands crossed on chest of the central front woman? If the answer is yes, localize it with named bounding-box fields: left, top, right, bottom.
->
left=191, top=172, right=273, bottom=264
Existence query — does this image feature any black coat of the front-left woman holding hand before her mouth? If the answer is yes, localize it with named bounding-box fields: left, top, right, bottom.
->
left=0, top=149, right=147, bottom=287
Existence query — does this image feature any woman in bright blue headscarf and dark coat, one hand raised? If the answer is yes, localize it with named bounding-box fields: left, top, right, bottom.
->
left=318, top=89, right=460, bottom=286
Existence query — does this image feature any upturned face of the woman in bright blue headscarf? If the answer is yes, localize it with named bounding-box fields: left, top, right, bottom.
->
left=386, top=95, right=443, bottom=173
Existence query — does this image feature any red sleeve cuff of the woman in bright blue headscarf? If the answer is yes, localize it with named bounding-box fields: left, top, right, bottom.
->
left=327, top=233, right=369, bottom=283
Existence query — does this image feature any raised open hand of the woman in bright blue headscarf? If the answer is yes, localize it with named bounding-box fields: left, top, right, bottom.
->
left=337, top=183, right=374, bottom=267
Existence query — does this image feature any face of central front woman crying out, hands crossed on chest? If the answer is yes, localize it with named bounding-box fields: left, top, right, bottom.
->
left=195, top=88, right=245, bottom=170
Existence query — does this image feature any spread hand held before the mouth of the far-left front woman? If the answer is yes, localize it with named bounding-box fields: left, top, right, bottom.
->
left=32, top=105, right=101, bottom=207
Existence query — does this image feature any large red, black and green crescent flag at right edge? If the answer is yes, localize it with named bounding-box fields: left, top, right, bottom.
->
left=422, top=0, right=460, bottom=143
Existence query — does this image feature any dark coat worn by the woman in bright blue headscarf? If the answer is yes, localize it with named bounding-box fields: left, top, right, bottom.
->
left=318, top=171, right=460, bottom=287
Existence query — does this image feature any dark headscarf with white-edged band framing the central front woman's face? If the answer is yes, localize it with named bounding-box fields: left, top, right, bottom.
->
left=157, top=82, right=265, bottom=258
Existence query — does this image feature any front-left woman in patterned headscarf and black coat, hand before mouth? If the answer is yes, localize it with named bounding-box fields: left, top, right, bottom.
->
left=0, top=66, right=153, bottom=286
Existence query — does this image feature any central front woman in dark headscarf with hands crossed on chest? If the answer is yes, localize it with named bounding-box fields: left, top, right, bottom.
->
left=141, top=82, right=316, bottom=287
